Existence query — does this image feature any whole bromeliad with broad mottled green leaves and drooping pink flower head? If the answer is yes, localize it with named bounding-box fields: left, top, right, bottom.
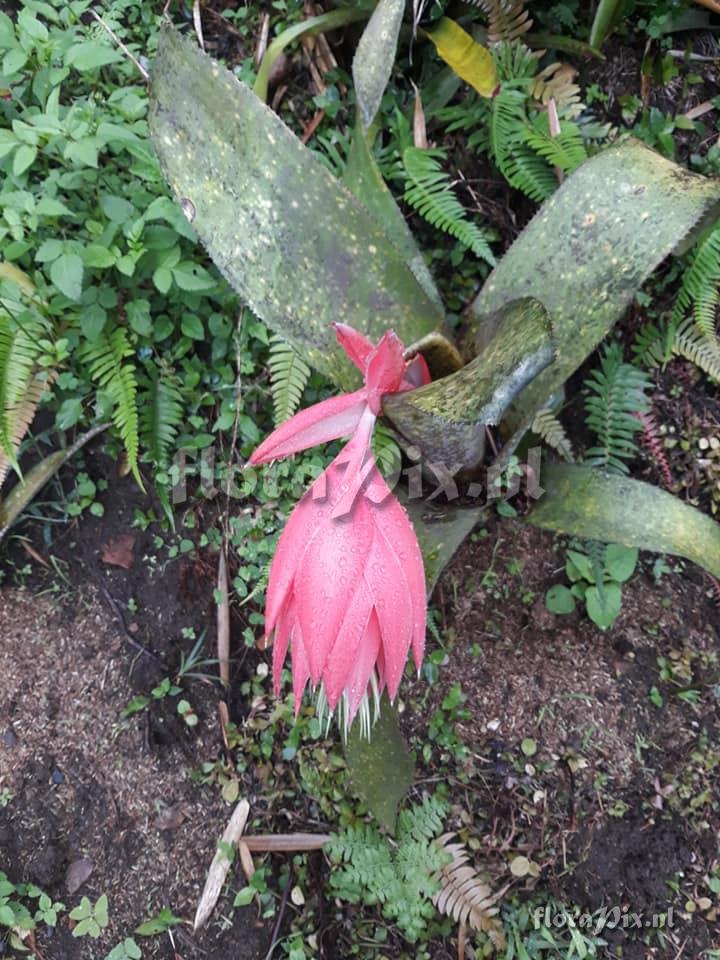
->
left=151, top=0, right=720, bottom=740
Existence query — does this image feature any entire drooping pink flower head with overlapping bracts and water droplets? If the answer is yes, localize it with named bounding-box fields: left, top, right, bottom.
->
left=250, top=324, right=430, bottom=726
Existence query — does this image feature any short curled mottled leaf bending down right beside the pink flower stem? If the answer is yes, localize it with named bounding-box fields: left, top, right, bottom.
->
left=383, top=297, right=554, bottom=467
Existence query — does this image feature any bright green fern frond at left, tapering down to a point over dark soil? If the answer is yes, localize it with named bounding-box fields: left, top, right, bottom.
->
left=83, top=327, right=143, bottom=487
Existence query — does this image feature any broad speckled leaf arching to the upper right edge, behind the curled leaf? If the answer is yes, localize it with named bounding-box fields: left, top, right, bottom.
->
left=467, top=140, right=720, bottom=432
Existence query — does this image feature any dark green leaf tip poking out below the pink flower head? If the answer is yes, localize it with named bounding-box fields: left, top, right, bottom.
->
left=345, top=695, right=415, bottom=833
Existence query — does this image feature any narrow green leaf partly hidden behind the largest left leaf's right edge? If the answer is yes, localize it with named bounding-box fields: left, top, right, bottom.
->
left=342, top=118, right=442, bottom=310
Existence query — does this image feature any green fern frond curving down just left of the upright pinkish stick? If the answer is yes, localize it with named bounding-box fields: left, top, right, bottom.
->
left=490, top=86, right=557, bottom=203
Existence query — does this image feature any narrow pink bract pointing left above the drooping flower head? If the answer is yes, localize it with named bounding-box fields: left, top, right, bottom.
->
left=250, top=390, right=366, bottom=465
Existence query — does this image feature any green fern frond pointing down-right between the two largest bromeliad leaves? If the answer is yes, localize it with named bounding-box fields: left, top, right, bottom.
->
left=403, top=147, right=495, bottom=266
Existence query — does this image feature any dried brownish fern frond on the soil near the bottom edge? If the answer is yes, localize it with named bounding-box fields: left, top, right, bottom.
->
left=433, top=833, right=505, bottom=950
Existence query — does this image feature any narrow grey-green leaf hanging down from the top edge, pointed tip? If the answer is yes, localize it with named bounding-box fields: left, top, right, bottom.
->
left=352, top=0, right=405, bottom=128
